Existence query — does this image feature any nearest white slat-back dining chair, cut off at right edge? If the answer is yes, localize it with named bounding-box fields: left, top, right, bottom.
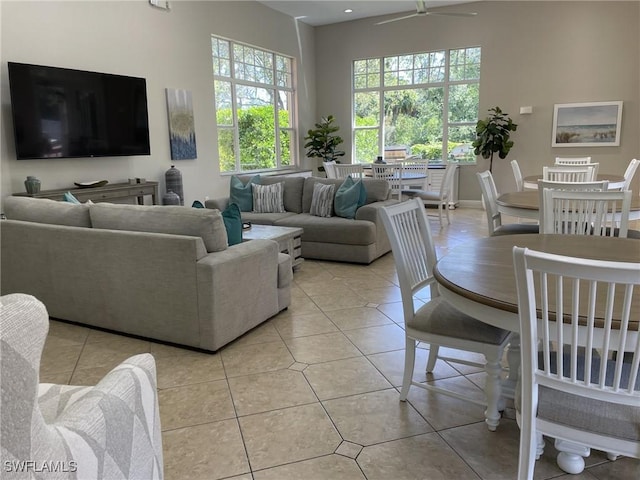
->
left=513, top=247, right=640, bottom=480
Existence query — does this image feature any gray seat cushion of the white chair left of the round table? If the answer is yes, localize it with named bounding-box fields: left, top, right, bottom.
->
left=406, top=297, right=510, bottom=345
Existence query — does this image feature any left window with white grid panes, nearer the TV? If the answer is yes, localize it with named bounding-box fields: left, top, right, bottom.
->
left=211, top=36, right=296, bottom=172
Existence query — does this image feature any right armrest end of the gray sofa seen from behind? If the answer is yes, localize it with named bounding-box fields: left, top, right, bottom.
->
left=197, top=240, right=278, bottom=351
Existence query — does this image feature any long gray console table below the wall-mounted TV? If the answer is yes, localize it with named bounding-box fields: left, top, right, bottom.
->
left=14, top=182, right=158, bottom=205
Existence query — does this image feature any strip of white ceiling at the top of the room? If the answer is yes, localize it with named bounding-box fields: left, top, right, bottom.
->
left=260, top=0, right=477, bottom=27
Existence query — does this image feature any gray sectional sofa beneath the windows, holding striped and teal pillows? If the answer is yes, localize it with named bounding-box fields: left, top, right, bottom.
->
left=205, top=176, right=397, bottom=264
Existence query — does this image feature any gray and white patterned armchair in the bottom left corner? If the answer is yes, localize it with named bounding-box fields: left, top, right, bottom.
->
left=0, top=294, right=163, bottom=480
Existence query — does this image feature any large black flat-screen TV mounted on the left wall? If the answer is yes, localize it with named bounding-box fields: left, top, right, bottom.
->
left=8, top=62, right=151, bottom=160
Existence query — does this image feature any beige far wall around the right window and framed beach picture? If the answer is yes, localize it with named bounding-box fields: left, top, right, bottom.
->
left=316, top=1, right=640, bottom=200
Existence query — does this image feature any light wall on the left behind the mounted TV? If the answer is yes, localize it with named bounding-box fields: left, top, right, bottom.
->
left=0, top=0, right=315, bottom=205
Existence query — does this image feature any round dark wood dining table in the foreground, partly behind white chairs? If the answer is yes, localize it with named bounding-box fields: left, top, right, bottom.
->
left=434, top=234, right=640, bottom=474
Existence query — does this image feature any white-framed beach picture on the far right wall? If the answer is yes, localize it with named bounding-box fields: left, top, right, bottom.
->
left=551, top=101, right=622, bottom=147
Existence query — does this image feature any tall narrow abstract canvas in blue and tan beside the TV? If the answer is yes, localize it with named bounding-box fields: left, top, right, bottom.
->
left=166, top=88, right=197, bottom=160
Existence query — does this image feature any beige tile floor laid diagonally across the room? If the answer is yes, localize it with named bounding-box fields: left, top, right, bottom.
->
left=41, top=209, right=640, bottom=480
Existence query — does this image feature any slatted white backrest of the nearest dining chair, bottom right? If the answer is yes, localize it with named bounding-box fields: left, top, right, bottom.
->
left=514, top=247, right=640, bottom=406
